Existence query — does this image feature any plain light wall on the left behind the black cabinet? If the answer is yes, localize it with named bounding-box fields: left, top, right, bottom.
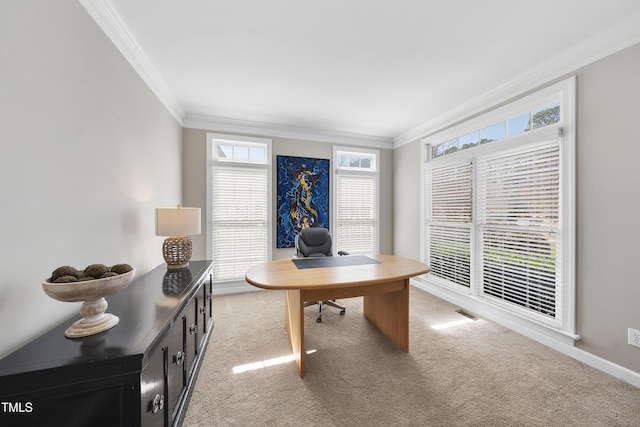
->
left=0, top=0, right=182, bottom=357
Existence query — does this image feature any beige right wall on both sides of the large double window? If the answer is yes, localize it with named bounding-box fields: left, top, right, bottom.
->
left=394, top=44, right=640, bottom=373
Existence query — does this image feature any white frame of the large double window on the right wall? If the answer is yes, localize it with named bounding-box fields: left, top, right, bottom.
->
left=419, top=77, right=580, bottom=345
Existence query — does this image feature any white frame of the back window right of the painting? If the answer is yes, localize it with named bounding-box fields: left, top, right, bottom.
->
left=331, top=145, right=380, bottom=255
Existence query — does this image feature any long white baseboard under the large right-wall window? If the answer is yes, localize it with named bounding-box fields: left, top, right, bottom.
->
left=411, top=279, right=640, bottom=388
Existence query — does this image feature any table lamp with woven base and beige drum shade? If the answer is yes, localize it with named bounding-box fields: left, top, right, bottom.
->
left=156, top=205, right=200, bottom=270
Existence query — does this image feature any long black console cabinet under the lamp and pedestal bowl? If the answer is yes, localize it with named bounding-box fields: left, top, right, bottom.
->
left=0, top=261, right=213, bottom=427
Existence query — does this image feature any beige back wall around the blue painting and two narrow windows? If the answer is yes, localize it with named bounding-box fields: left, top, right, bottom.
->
left=183, top=129, right=393, bottom=259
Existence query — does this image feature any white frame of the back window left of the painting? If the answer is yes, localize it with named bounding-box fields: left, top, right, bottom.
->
left=205, top=132, right=273, bottom=292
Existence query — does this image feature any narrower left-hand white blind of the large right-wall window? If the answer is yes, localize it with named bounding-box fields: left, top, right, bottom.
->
left=424, top=162, right=473, bottom=287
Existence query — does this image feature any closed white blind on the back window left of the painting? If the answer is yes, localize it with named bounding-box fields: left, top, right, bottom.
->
left=211, top=163, right=268, bottom=282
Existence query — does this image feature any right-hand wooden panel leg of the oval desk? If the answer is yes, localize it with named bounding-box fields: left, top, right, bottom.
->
left=363, top=279, right=409, bottom=353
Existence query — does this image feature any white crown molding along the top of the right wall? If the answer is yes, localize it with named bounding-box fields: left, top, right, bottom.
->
left=393, top=13, right=640, bottom=148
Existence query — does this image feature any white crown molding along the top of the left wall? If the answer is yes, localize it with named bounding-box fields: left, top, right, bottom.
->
left=78, top=0, right=185, bottom=125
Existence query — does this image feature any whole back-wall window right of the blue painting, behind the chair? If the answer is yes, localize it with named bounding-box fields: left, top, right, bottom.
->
left=334, top=148, right=379, bottom=255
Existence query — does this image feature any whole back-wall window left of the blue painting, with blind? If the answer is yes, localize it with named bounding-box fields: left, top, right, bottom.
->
left=207, top=134, right=271, bottom=282
